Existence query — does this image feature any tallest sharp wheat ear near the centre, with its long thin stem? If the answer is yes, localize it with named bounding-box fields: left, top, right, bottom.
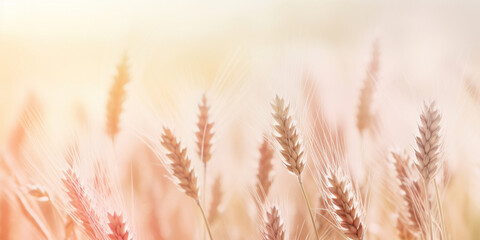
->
left=272, top=96, right=319, bottom=240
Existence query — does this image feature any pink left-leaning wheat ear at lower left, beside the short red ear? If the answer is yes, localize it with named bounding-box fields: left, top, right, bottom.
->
left=62, top=169, right=107, bottom=239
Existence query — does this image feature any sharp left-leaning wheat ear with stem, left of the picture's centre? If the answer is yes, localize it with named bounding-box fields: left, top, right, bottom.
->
left=162, top=128, right=213, bottom=240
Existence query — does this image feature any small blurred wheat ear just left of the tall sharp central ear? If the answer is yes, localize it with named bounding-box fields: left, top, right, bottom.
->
left=256, top=139, right=273, bottom=203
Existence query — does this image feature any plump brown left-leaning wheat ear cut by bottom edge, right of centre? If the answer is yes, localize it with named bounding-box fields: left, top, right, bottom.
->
left=327, top=173, right=365, bottom=240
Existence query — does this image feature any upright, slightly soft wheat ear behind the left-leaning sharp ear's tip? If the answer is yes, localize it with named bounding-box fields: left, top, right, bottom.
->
left=195, top=94, right=214, bottom=164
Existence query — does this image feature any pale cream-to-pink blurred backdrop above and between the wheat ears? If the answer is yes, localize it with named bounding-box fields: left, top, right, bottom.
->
left=0, top=0, right=480, bottom=239
